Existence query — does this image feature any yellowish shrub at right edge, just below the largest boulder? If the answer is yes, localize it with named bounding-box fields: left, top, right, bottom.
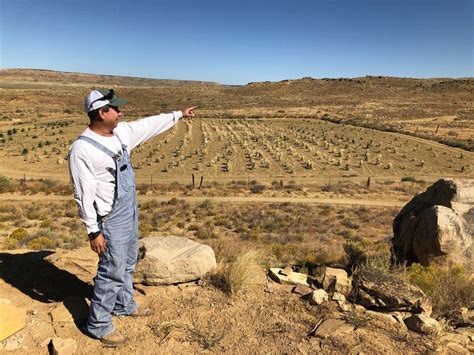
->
left=407, top=264, right=474, bottom=318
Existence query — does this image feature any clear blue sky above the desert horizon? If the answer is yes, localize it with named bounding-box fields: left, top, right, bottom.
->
left=0, top=0, right=474, bottom=84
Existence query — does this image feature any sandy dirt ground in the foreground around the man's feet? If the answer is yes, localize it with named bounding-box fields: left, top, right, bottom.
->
left=0, top=247, right=450, bottom=354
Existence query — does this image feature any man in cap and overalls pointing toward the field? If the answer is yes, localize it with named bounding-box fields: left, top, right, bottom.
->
left=68, top=89, right=196, bottom=345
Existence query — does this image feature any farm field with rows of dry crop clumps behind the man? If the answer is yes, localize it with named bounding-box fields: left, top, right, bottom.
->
left=0, top=118, right=474, bottom=182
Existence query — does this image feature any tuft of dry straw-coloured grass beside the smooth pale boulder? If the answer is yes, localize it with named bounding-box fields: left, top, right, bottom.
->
left=211, top=250, right=259, bottom=295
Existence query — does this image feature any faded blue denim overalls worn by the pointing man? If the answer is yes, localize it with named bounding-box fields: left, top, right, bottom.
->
left=78, top=136, right=138, bottom=338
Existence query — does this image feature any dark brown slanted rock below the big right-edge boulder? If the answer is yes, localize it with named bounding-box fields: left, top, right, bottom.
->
left=350, top=268, right=432, bottom=315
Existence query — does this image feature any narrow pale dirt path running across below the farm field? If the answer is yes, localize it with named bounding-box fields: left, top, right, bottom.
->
left=0, top=193, right=406, bottom=207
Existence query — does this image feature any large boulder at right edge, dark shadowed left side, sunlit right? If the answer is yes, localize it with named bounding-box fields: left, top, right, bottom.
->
left=392, top=179, right=474, bottom=269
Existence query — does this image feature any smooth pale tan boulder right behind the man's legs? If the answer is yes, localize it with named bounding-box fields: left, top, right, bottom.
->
left=133, top=236, right=216, bottom=286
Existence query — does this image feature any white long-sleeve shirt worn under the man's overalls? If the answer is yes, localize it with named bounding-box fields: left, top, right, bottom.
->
left=68, top=111, right=183, bottom=233
